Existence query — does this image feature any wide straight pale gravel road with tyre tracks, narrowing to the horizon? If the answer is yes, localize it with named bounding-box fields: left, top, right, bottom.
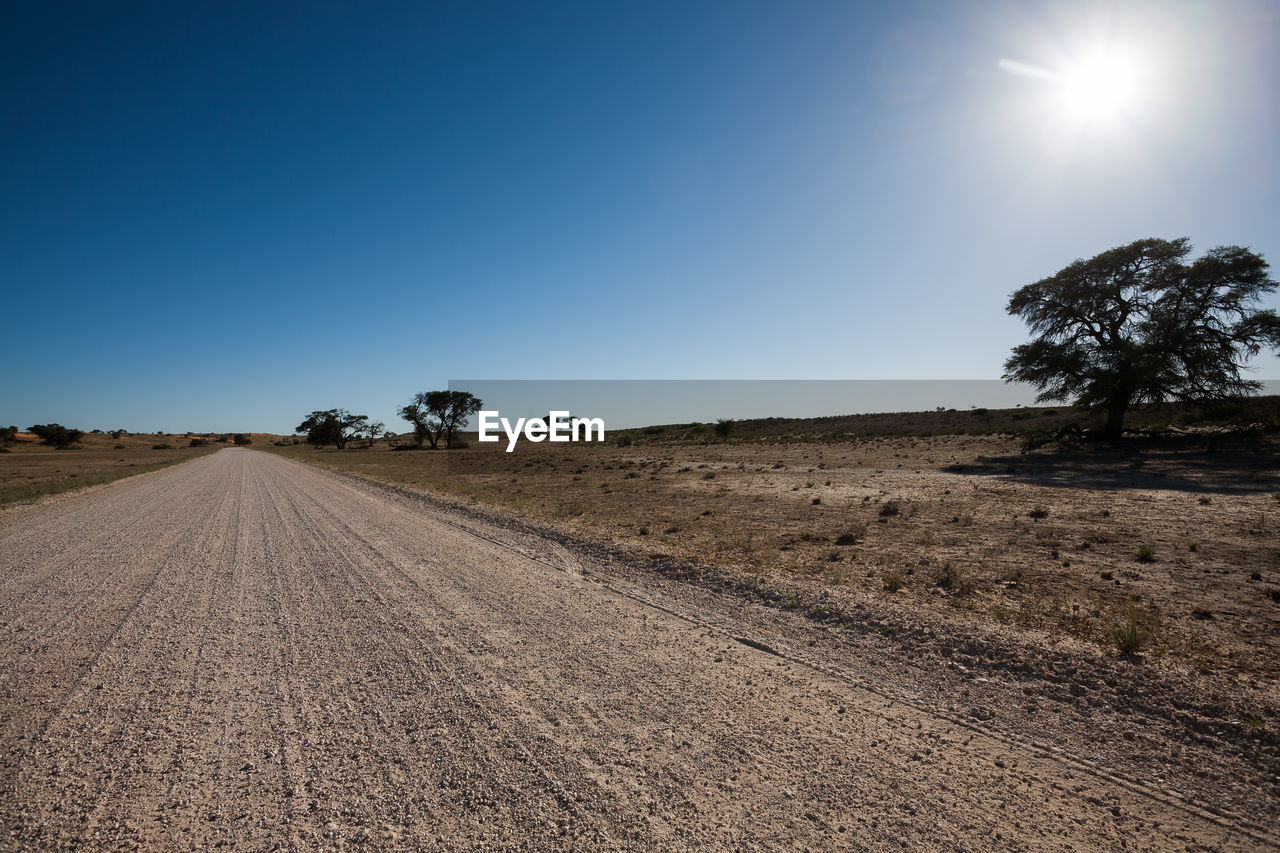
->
left=0, top=450, right=1274, bottom=850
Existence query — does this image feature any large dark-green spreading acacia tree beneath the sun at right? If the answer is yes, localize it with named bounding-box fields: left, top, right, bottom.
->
left=1005, top=237, right=1280, bottom=438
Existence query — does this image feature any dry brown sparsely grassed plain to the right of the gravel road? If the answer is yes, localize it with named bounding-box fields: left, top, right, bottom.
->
left=259, top=414, right=1280, bottom=671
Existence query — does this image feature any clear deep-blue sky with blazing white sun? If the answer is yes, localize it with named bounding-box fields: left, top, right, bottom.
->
left=0, top=0, right=1280, bottom=432
